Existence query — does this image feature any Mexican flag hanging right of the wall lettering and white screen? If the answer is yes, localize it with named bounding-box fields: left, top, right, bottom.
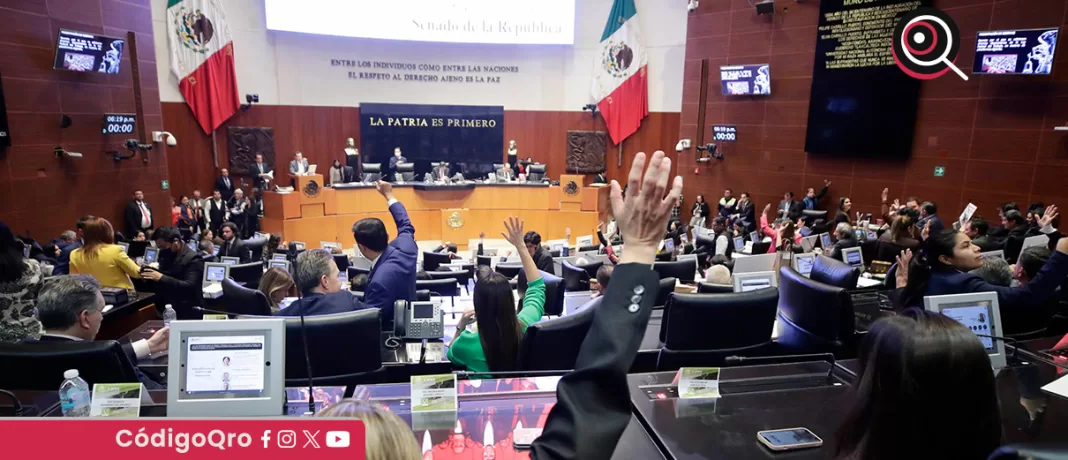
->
left=593, top=0, right=649, bottom=144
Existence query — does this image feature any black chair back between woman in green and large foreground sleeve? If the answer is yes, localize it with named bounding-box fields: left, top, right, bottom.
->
left=516, top=307, right=597, bottom=370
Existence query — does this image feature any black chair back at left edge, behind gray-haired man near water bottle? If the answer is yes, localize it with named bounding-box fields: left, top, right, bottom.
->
left=0, top=340, right=139, bottom=392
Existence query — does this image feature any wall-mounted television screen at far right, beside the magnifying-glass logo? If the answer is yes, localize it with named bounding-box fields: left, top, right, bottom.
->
left=972, top=27, right=1058, bottom=75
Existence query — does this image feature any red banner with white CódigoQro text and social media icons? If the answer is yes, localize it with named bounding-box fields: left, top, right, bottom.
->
left=0, top=417, right=366, bottom=460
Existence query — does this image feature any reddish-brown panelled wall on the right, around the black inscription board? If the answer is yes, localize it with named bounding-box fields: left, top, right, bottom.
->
left=678, top=0, right=1068, bottom=219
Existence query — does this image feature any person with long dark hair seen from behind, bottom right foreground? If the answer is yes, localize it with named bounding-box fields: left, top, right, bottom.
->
left=835, top=308, right=1002, bottom=460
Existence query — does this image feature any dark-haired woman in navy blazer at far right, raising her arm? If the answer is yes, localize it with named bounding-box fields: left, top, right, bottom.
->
left=898, top=221, right=1068, bottom=310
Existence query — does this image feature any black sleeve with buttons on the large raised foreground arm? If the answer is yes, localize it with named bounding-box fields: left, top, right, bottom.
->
left=531, top=264, right=659, bottom=460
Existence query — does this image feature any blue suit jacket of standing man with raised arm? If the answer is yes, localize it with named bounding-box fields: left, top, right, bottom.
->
left=365, top=202, right=419, bottom=327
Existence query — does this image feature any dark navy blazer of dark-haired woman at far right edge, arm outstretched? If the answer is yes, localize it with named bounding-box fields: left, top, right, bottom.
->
left=927, top=251, right=1068, bottom=310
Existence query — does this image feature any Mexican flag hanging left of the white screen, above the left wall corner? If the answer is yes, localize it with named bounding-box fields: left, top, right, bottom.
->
left=167, top=0, right=241, bottom=133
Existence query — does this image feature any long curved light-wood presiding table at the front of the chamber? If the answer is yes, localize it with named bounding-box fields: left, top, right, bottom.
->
left=261, top=175, right=609, bottom=249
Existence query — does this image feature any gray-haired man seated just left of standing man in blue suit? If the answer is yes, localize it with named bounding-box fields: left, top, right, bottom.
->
left=274, top=249, right=366, bottom=316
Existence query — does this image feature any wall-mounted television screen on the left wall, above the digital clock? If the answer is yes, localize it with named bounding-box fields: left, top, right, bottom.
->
left=54, top=29, right=126, bottom=74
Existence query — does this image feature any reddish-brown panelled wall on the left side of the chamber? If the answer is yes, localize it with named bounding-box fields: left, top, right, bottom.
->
left=0, top=0, right=165, bottom=241
